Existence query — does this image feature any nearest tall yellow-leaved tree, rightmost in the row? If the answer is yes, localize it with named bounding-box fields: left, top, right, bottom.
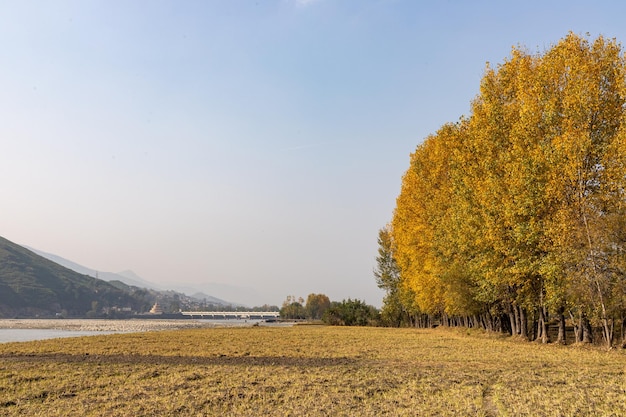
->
left=541, top=33, right=626, bottom=346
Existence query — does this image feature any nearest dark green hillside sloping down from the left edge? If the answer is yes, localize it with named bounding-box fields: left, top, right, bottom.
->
left=0, top=237, right=146, bottom=317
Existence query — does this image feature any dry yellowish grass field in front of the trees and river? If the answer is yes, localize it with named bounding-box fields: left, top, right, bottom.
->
left=0, top=326, right=626, bottom=417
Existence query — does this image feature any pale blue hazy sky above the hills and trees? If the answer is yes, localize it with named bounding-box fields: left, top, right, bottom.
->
left=0, top=0, right=626, bottom=306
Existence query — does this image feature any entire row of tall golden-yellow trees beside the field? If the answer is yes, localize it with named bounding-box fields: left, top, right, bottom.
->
left=375, top=33, right=626, bottom=347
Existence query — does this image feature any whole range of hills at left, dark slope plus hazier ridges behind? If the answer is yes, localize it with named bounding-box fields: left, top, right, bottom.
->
left=0, top=237, right=244, bottom=318
